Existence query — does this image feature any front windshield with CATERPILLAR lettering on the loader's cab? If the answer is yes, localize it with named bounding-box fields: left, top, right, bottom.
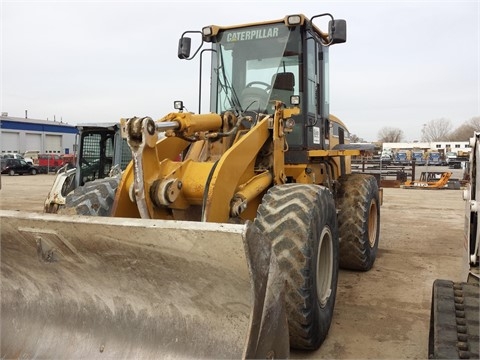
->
left=211, top=23, right=301, bottom=113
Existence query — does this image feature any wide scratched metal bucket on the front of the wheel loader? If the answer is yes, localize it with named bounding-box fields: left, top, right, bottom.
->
left=0, top=210, right=289, bottom=359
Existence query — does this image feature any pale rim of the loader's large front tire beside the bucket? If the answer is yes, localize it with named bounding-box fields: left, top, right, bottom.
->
left=316, top=226, right=333, bottom=308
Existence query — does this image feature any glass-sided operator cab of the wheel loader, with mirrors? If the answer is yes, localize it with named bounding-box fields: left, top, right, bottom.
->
left=179, top=14, right=346, bottom=163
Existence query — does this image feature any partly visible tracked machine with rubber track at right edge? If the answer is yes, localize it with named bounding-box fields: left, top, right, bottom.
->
left=428, top=132, right=480, bottom=359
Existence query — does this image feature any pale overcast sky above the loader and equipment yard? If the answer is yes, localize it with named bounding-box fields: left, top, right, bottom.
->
left=0, top=0, right=480, bottom=141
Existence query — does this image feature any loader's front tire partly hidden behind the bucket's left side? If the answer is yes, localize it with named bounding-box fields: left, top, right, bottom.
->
left=58, top=176, right=120, bottom=216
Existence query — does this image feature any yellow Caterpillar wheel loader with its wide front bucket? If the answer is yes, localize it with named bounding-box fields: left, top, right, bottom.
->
left=0, top=14, right=382, bottom=358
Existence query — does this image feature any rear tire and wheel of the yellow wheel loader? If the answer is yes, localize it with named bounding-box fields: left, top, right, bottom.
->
left=337, top=174, right=380, bottom=271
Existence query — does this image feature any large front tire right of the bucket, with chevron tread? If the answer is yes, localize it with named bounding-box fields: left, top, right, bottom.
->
left=255, top=184, right=338, bottom=350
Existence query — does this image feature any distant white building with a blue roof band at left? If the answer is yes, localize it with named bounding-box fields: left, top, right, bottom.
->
left=0, top=113, right=78, bottom=154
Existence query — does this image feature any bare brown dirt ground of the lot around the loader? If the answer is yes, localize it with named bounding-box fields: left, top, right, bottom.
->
left=0, top=170, right=466, bottom=359
